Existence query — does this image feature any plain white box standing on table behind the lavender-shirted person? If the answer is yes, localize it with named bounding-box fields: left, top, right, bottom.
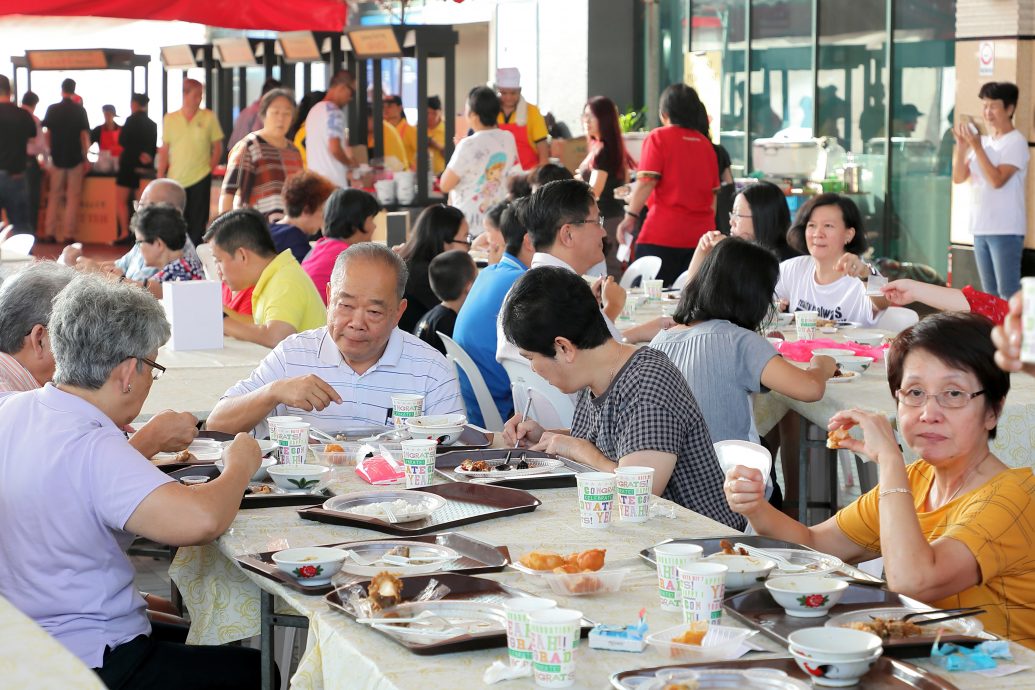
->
left=161, top=280, right=223, bottom=350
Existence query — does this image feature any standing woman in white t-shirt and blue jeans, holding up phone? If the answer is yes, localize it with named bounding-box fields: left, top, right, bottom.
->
left=952, top=82, right=1028, bottom=299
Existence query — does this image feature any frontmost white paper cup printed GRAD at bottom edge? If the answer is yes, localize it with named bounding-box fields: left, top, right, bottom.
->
left=528, top=608, right=582, bottom=688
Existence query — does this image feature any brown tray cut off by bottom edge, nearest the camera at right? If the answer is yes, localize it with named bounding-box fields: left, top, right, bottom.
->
left=611, top=657, right=958, bottom=690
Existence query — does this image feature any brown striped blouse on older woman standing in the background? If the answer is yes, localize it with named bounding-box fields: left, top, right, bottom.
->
left=223, top=132, right=302, bottom=220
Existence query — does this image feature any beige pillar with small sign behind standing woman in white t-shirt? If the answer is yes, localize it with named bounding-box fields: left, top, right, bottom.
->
left=952, top=0, right=1035, bottom=248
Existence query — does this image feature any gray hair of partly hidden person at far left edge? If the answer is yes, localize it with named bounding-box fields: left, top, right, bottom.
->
left=0, top=261, right=76, bottom=355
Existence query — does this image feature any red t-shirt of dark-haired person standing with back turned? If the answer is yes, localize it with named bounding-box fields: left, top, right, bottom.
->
left=638, top=125, right=719, bottom=249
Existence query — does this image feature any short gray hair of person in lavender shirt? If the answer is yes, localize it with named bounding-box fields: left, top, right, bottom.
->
left=50, top=275, right=171, bottom=390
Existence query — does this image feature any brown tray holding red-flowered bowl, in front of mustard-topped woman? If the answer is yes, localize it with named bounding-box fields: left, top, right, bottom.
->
left=722, top=583, right=983, bottom=659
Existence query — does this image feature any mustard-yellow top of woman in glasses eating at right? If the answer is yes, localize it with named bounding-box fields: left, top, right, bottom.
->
left=836, top=460, right=1035, bottom=649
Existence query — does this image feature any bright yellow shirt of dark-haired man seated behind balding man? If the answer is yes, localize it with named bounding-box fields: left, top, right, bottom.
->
left=252, top=249, right=327, bottom=333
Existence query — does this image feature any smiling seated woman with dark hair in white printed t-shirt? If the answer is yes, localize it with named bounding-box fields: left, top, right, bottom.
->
left=775, top=194, right=887, bottom=326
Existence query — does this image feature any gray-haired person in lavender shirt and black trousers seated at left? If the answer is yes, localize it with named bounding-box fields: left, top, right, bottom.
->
left=0, top=275, right=260, bottom=688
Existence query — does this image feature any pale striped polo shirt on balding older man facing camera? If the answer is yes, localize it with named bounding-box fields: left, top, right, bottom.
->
left=223, top=327, right=464, bottom=434
